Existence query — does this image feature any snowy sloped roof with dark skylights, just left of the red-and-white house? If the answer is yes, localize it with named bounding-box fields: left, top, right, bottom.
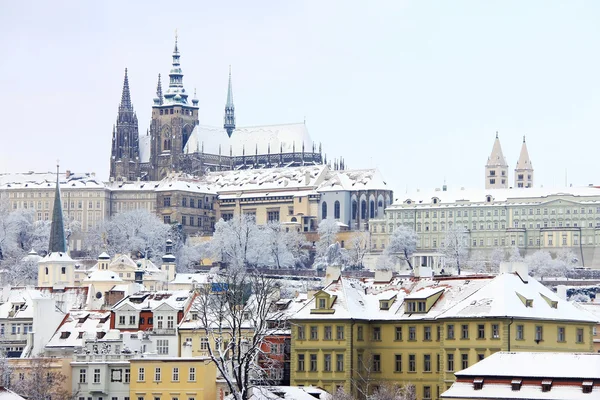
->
left=46, top=311, right=110, bottom=348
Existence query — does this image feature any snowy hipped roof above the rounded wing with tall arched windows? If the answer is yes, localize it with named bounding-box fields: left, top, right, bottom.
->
left=317, top=168, right=389, bottom=192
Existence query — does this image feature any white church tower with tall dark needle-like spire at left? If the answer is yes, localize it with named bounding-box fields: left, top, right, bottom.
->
left=38, top=165, right=75, bottom=287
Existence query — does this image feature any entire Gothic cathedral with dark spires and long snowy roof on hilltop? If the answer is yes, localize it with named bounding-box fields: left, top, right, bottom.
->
left=110, top=38, right=324, bottom=181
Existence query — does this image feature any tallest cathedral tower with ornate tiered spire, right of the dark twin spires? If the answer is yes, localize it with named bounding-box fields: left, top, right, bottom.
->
left=149, top=36, right=198, bottom=180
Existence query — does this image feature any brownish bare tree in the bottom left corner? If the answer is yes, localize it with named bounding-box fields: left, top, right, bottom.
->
left=10, top=357, right=76, bottom=400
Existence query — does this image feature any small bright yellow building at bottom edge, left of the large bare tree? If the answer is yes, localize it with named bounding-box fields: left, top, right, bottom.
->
left=129, top=357, right=217, bottom=400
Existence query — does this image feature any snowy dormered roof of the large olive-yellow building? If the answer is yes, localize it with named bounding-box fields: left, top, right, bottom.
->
left=291, top=273, right=594, bottom=323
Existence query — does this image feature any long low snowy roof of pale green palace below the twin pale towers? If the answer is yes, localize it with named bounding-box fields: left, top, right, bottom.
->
left=388, top=186, right=600, bottom=209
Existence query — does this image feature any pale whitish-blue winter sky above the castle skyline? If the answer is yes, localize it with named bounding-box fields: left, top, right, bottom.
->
left=0, top=0, right=600, bottom=194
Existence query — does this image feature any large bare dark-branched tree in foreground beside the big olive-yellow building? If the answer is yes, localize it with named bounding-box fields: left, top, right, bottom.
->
left=192, top=268, right=285, bottom=400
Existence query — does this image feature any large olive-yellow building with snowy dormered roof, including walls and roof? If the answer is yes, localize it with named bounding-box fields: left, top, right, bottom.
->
left=291, top=264, right=595, bottom=399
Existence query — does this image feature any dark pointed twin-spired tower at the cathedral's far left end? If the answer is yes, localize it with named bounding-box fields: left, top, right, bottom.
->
left=110, top=68, right=140, bottom=181
